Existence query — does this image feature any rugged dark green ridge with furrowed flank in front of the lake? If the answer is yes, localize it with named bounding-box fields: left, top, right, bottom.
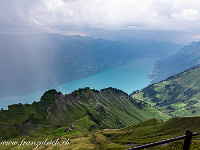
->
left=0, top=88, right=168, bottom=128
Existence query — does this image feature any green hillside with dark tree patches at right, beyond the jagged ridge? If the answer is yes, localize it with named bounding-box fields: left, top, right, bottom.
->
left=132, top=67, right=200, bottom=116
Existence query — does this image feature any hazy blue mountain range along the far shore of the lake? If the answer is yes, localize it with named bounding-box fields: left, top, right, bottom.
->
left=0, top=33, right=180, bottom=96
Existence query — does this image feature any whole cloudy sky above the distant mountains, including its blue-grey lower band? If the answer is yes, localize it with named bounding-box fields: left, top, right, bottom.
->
left=0, top=0, right=200, bottom=43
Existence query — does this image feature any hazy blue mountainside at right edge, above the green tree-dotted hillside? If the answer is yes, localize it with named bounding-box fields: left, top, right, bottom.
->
left=151, top=42, right=200, bottom=83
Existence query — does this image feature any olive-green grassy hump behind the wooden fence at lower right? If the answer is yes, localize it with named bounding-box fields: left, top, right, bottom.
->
left=103, top=117, right=200, bottom=149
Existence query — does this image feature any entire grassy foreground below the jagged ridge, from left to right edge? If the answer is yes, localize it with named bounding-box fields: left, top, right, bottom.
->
left=0, top=116, right=200, bottom=150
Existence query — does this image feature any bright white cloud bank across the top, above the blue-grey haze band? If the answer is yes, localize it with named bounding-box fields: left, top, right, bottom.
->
left=0, top=0, right=200, bottom=32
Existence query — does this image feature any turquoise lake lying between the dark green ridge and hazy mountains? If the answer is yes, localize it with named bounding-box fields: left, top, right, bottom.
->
left=0, top=58, right=157, bottom=109
